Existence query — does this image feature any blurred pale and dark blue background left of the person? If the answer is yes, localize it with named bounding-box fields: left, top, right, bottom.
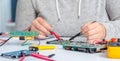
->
left=0, top=0, right=17, bottom=32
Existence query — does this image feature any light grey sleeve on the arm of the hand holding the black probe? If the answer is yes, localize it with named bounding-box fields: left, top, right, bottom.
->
left=102, top=0, right=120, bottom=40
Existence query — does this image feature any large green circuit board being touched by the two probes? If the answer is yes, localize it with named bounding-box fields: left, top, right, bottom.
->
left=47, top=40, right=107, bottom=53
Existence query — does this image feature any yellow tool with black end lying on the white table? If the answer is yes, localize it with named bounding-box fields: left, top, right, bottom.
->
left=29, top=45, right=55, bottom=51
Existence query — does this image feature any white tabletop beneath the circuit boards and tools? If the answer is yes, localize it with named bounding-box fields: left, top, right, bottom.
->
left=0, top=38, right=120, bottom=61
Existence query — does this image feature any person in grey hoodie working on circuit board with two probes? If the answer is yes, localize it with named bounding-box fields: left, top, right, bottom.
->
left=16, top=0, right=120, bottom=43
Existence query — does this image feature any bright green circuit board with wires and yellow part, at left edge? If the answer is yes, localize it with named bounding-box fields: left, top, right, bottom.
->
left=0, top=31, right=39, bottom=46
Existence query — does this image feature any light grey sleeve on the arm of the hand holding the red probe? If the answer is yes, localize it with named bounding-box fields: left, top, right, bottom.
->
left=15, top=0, right=36, bottom=30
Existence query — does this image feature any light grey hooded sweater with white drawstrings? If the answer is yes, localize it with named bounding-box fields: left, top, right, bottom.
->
left=16, top=0, right=120, bottom=39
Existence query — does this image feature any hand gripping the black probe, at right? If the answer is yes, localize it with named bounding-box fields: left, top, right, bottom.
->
left=81, top=22, right=106, bottom=44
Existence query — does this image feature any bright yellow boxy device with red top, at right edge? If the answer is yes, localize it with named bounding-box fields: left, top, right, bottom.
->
left=107, top=38, right=120, bottom=58
